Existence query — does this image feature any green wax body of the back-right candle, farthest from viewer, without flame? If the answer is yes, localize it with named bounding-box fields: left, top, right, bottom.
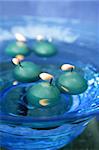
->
left=34, top=41, right=57, bottom=57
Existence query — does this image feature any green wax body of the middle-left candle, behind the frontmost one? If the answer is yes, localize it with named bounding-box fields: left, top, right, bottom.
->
left=13, top=61, right=41, bottom=82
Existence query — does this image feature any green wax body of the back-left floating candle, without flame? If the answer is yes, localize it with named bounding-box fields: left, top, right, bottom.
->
left=5, top=42, right=30, bottom=57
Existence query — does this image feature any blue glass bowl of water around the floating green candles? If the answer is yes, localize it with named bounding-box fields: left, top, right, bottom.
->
left=0, top=17, right=99, bottom=150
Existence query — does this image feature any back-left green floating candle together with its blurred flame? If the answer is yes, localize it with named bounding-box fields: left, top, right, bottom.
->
left=5, top=33, right=30, bottom=57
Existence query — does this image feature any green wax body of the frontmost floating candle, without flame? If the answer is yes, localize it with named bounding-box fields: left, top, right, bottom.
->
left=27, top=82, right=60, bottom=107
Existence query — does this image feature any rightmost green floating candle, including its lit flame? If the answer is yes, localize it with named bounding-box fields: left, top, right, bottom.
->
left=57, top=64, right=88, bottom=95
